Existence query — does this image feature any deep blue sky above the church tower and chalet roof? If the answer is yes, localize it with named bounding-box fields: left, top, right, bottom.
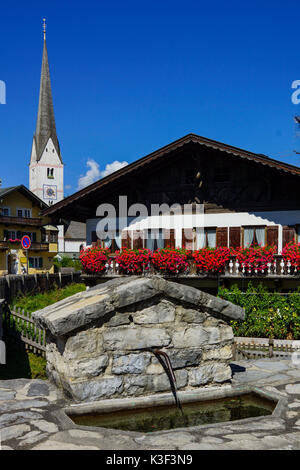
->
left=0, top=0, right=300, bottom=194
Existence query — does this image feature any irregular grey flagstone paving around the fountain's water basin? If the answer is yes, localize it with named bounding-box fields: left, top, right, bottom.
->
left=0, top=358, right=300, bottom=451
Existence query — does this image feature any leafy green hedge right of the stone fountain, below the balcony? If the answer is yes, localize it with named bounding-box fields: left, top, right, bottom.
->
left=218, top=283, right=300, bottom=339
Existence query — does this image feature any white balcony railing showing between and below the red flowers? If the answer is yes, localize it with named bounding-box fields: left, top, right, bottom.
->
left=82, top=254, right=300, bottom=278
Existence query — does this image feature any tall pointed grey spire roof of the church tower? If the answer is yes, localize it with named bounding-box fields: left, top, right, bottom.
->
left=34, top=38, right=62, bottom=162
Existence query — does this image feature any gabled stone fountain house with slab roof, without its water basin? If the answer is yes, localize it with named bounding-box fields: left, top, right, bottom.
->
left=33, top=276, right=245, bottom=402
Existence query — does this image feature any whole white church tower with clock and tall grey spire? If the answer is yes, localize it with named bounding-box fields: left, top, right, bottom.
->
left=29, top=19, right=64, bottom=205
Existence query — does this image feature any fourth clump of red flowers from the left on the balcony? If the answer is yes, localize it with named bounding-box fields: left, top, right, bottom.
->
left=192, top=246, right=230, bottom=273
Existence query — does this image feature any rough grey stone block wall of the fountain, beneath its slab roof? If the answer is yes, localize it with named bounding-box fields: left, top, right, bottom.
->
left=46, top=299, right=233, bottom=401
